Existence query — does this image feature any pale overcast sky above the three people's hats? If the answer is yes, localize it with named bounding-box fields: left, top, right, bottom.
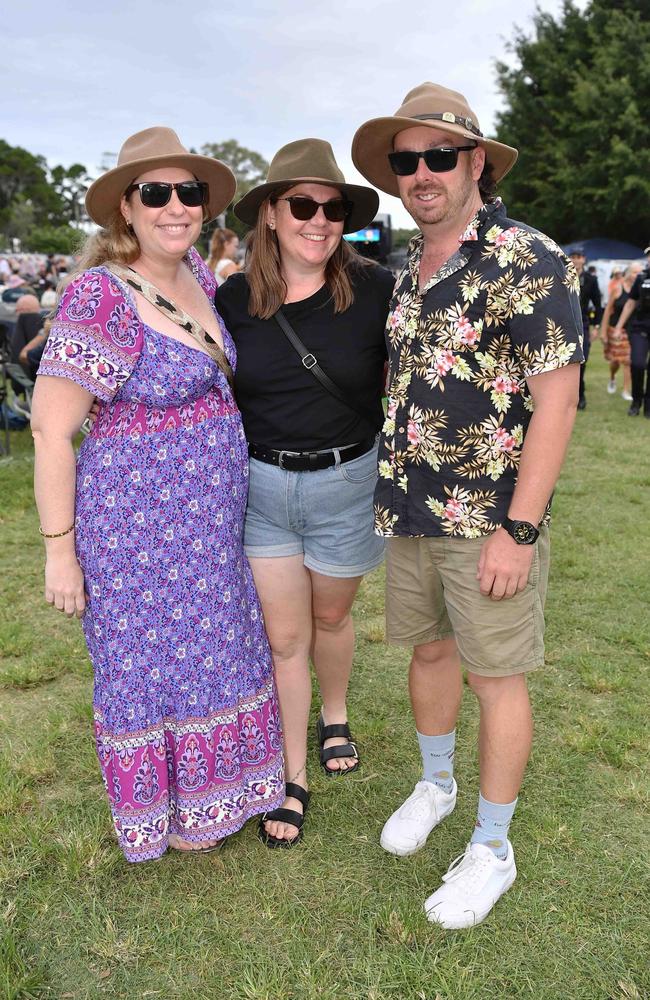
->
left=0, top=0, right=572, bottom=226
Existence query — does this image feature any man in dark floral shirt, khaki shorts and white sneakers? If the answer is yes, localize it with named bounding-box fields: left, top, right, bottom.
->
left=352, top=83, right=583, bottom=928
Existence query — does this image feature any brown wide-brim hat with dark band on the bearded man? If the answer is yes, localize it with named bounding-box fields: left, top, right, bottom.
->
left=352, top=82, right=519, bottom=197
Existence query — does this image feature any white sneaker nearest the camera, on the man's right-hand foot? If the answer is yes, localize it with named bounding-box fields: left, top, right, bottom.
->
left=424, top=841, right=517, bottom=930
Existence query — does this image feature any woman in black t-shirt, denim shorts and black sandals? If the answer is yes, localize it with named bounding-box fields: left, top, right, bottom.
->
left=215, top=139, right=393, bottom=847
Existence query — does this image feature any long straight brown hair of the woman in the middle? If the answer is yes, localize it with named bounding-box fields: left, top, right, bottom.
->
left=246, top=192, right=372, bottom=319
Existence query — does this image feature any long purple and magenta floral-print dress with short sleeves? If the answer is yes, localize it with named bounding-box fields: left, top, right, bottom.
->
left=39, top=250, right=284, bottom=861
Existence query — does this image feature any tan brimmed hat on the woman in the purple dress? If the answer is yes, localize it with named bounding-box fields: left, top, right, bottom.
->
left=86, top=125, right=237, bottom=226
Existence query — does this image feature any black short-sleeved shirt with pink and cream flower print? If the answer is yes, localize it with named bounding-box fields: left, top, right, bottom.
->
left=375, top=200, right=583, bottom=538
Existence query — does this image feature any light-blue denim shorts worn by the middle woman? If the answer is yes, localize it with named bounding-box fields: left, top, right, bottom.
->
left=244, top=446, right=384, bottom=577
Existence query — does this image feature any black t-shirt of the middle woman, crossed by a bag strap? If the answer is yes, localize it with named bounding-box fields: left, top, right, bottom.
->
left=215, top=264, right=395, bottom=451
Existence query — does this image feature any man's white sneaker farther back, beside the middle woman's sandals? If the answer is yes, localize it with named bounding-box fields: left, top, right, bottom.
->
left=379, top=781, right=458, bottom=857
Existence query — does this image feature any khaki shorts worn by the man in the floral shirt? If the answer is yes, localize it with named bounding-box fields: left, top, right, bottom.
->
left=386, top=527, right=550, bottom=677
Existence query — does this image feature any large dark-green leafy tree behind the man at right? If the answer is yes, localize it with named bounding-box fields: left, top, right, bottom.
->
left=496, top=0, right=650, bottom=247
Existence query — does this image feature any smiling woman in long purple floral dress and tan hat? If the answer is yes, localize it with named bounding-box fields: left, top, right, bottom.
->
left=32, top=128, right=284, bottom=861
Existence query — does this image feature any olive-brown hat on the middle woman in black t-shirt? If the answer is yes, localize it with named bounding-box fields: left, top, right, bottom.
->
left=234, top=139, right=379, bottom=233
